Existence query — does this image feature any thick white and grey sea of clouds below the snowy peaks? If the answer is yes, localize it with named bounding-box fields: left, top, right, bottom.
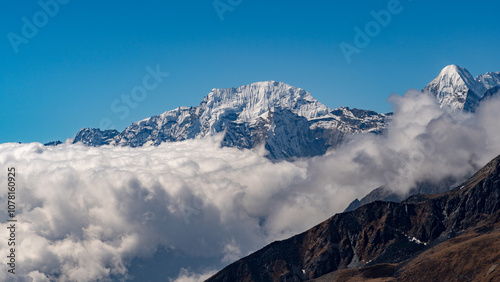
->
left=0, top=91, right=500, bottom=281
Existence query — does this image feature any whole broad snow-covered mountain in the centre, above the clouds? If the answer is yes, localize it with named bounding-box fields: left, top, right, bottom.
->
left=70, top=81, right=391, bottom=160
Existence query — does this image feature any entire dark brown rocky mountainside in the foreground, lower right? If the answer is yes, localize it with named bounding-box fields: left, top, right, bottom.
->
left=207, top=156, right=500, bottom=282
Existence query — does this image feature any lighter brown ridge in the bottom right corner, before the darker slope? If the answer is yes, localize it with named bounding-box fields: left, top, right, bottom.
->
left=311, top=212, right=500, bottom=282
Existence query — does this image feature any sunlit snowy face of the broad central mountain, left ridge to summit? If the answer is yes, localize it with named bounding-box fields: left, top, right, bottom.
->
left=117, top=81, right=329, bottom=146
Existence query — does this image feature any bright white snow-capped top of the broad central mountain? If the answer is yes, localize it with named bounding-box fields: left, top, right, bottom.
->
left=200, top=81, right=330, bottom=122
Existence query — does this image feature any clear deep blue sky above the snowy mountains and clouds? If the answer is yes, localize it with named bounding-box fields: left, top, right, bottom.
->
left=0, top=0, right=500, bottom=143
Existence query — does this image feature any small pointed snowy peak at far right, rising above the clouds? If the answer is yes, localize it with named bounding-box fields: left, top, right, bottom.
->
left=423, top=65, right=500, bottom=112
